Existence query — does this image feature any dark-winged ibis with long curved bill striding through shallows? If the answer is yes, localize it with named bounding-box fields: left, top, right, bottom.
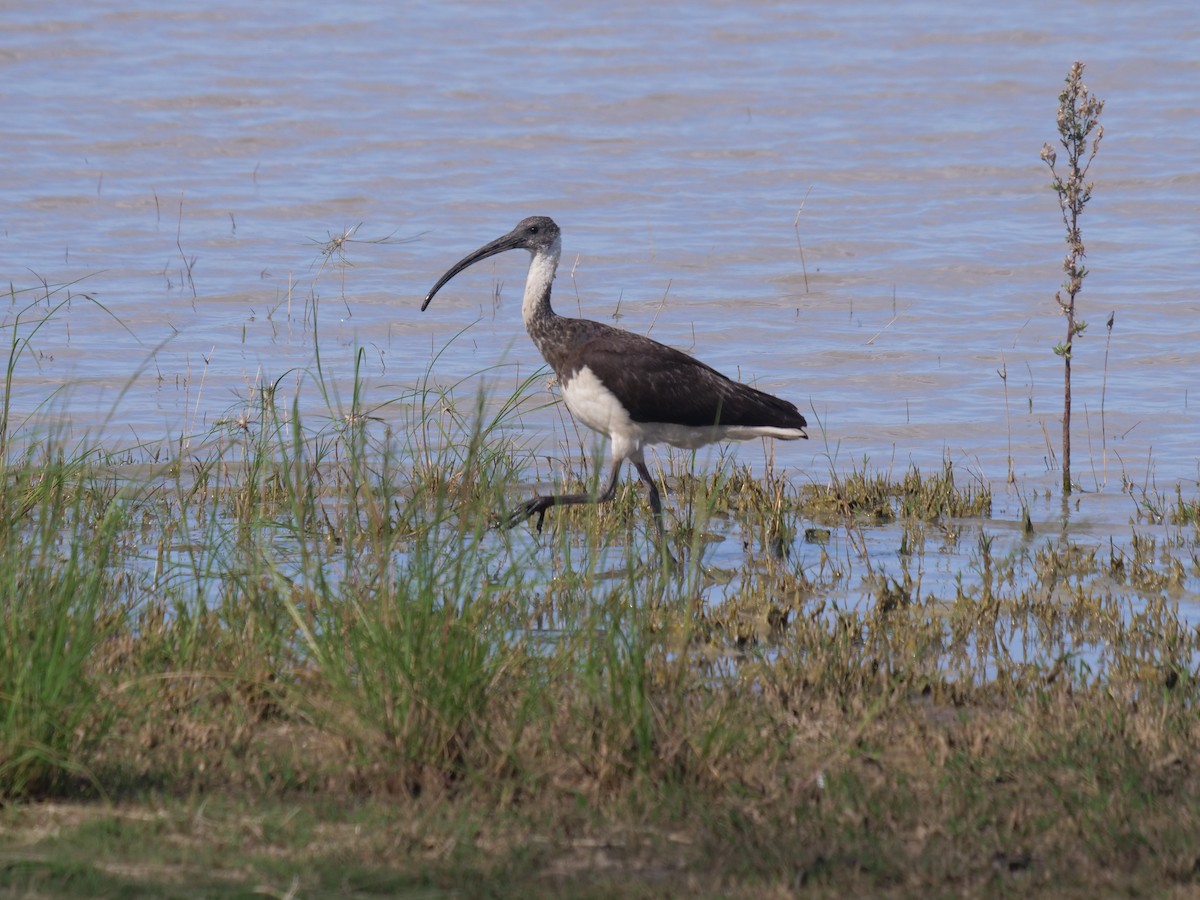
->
left=421, top=216, right=808, bottom=540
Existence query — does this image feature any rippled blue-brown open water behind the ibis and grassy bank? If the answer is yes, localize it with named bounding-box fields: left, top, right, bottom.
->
left=0, top=0, right=1200, bottom=614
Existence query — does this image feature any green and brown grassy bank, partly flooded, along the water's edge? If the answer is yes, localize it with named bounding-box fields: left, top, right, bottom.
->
left=0, top=301, right=1200, bottom=896
